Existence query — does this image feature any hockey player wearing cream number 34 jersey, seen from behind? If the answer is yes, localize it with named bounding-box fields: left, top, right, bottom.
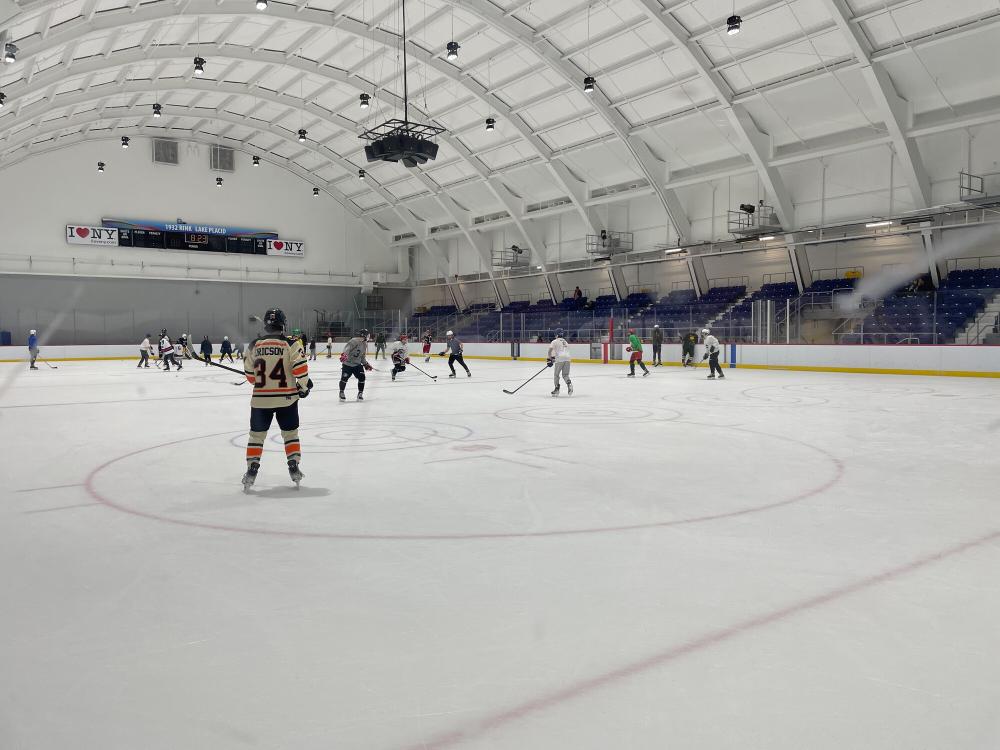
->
left=243, top=308, right=312, bottom=492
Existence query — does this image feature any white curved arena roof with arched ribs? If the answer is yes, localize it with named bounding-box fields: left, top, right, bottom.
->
left=0, top=0, right=1000, bottom=232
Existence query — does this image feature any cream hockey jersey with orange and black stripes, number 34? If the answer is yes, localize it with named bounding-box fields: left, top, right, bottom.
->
left=243, top=334, right=309, bottom=409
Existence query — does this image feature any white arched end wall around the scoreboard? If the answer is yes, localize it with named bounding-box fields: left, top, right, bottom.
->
left=0, top=138, right=396, bottom=284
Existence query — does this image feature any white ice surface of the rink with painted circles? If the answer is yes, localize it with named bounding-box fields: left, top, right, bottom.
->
left=0, top=358, right=1000, bottom=750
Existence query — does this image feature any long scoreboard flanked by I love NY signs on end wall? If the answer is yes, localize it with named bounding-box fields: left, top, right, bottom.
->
left=66, top=219, right=305, bottom=258
